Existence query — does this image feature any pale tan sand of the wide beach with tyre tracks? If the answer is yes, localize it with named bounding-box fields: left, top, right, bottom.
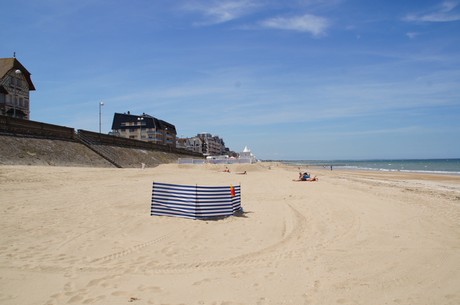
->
left=0, top=163, right=460, bottom=305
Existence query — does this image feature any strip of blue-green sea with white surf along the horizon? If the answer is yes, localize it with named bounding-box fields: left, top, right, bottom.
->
left=281, top=159, right=460, bottom=175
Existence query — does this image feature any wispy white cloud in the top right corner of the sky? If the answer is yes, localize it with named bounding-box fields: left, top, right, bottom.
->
left=404, top=1, right=460, bottom=22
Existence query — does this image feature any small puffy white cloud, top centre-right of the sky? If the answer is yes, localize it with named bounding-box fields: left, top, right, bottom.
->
left=260, top=14, right=330, bottom=36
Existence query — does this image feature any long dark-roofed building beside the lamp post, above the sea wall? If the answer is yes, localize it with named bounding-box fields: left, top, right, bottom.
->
left=111, top=111, right=177, bottom=147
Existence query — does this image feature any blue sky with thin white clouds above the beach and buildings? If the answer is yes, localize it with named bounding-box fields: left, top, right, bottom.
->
left=0, top=0, right=460, bottom=160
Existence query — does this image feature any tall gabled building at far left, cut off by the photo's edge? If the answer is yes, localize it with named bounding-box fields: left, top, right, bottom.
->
left=0, top=57, right=35, bottom=120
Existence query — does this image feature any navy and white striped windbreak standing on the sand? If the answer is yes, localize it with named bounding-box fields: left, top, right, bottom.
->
left=150, top=182, right=242, bottom=219
